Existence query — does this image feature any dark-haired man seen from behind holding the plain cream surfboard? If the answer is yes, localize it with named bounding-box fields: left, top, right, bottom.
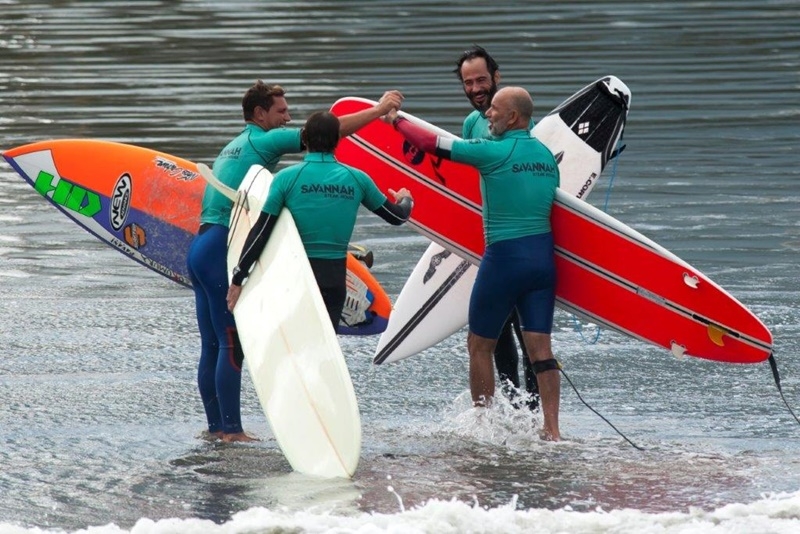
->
left=228, top=111, right=413, bottom=328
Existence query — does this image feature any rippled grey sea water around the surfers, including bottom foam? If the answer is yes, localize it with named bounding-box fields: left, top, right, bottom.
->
left=0, top=0, right=800, bottom=534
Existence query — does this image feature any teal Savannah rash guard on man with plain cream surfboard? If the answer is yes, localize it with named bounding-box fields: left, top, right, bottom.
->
left=263, top=152, right=386, bottom=260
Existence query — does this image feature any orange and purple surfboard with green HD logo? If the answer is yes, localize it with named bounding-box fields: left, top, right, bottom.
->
left=3, top=139, right=391, bottom=335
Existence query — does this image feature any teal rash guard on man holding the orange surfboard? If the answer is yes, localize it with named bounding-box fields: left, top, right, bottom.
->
left=200, top=123, right=303, bottom=226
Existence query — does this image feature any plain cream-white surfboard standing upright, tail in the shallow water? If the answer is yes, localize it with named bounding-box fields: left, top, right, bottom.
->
left=212, top=165, right=361, bottom=478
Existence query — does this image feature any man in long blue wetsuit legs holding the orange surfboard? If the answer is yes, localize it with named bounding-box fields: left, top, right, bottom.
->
left=187, top=80, right=403, bottom=441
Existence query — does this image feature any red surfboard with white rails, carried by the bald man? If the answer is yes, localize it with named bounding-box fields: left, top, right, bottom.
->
left=333, top=90, right=772, bottom=363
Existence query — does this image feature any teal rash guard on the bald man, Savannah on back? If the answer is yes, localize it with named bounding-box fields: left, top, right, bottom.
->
left=450, top=130, right=560, bottom=246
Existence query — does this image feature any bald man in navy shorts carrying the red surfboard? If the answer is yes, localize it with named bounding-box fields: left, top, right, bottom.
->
left=385, top=87, right=561, bottom=441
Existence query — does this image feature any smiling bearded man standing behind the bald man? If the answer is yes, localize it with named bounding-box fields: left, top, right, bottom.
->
left=453, top=45, right=539, bottom=409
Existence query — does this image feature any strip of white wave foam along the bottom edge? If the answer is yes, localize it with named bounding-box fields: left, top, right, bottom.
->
left=0, top=492, right=800, bottom=534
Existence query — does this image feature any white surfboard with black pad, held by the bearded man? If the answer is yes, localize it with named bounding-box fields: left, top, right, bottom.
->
left=373, top=76, right=631, bottom=364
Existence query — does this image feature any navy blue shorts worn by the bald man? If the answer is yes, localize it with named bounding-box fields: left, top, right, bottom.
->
left=469, top=232, right=556, bottom=339
